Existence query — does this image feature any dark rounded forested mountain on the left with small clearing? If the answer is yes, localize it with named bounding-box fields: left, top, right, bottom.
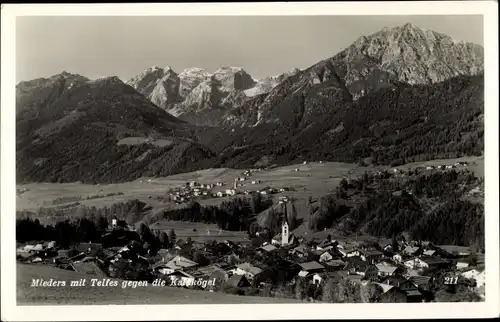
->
left=16, top=76, right=213, bottom=182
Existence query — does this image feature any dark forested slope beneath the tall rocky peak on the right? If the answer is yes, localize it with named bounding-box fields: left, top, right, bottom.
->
left=200, top=76, right=484, bottom=167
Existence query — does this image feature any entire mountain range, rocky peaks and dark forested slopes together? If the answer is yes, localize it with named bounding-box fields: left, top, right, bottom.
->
left=16, top=24, right=484, bottom=182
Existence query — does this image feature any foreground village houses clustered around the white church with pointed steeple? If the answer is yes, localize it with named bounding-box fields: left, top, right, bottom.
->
left=17, top=204, right=484, bottom=302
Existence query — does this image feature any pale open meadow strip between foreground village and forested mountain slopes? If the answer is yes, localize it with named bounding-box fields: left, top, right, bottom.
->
left=17, top=157, right=484, bottom=216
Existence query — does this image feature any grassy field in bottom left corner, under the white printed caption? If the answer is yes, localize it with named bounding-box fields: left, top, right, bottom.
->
left=17, top=264, right=300, bottom=305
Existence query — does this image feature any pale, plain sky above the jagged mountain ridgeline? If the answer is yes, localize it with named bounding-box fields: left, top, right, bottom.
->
left=16, top=16, right=483, bottom=82
